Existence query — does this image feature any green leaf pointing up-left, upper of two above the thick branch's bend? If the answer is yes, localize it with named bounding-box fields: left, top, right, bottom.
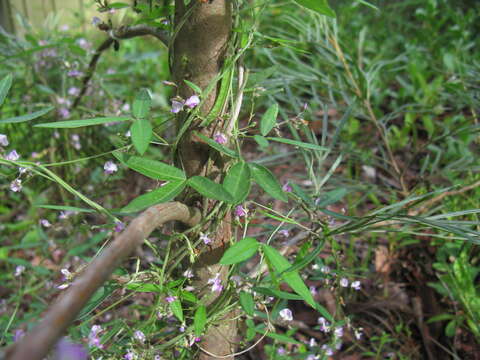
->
left=118, top=152, right=187, bottom=181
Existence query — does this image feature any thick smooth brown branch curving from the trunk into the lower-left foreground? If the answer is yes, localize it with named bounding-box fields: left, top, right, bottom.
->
left=6, top=202, right=201, bottom=360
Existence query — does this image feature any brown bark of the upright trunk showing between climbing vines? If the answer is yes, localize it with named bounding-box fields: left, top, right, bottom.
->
left=171, top=0, right=237, bottom=360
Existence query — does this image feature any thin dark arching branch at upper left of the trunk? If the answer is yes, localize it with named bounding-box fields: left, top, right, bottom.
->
left=70, top=25, right=169, bottom=110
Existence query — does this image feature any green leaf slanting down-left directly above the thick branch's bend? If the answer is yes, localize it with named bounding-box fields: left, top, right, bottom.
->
left=121, top=181, right=186, bottom=213
